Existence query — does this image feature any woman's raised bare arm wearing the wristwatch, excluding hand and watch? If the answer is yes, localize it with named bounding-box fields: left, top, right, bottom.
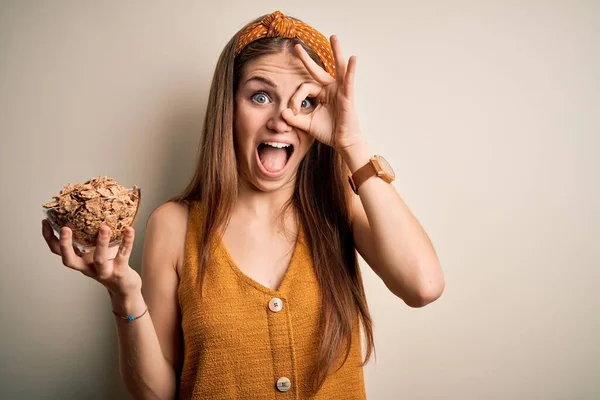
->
left=343, top=143, right=444, bottom=307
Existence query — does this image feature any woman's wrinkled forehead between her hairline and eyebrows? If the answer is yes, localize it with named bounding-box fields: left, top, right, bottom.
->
left=242, top=51, right=313, bottom=84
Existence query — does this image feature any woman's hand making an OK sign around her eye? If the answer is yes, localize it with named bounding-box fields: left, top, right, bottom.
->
left=282, top=35, right=361, bottom=152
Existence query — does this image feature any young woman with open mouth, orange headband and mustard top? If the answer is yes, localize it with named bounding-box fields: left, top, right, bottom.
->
left=43, top=12, right=444, bottom=400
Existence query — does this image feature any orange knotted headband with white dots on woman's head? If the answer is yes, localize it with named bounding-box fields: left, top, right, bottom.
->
left=235, top=11, right=335, bottom=78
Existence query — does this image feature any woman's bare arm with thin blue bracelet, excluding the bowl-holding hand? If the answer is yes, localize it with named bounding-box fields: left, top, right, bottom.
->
left=112, top=203, right=186, bottom=399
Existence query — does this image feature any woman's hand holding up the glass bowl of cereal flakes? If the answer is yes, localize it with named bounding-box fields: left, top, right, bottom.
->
left=42, top=220, right=142, bottom=299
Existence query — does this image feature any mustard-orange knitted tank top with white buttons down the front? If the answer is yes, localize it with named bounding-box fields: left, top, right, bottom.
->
left=178, top=202, right=366, bottom=400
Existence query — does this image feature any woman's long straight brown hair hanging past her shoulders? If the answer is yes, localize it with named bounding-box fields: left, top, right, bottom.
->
left=171, top=13, right=374, bottom=392
